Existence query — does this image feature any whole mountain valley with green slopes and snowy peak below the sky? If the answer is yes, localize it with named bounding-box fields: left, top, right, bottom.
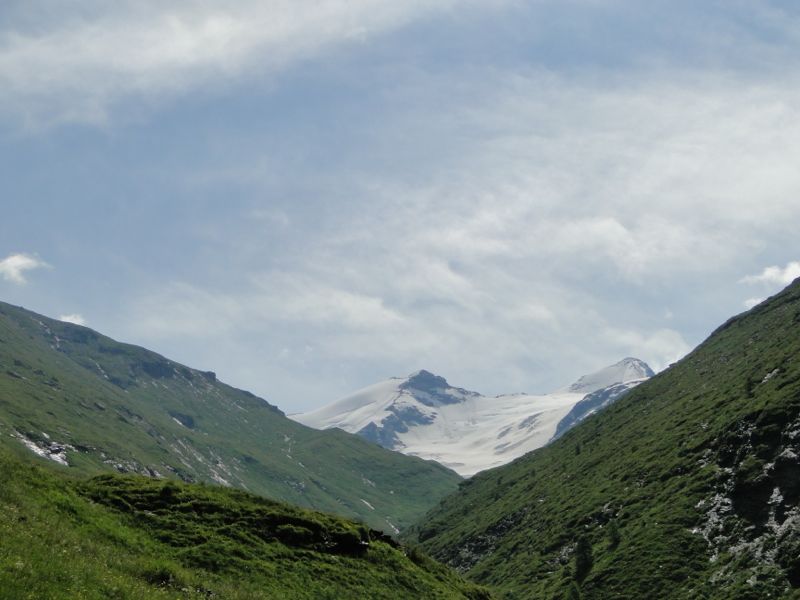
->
left=0, top=281, right=800, bottom=600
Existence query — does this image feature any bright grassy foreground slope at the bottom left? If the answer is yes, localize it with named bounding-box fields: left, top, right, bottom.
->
left=0, top=448, right=488, bottom=600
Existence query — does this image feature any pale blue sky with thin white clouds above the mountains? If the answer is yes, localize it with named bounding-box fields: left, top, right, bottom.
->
left=0, top=0, right=800, bottom=413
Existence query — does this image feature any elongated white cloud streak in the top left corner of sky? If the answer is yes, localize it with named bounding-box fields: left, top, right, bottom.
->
left=0, top=0, right=455, bottom=123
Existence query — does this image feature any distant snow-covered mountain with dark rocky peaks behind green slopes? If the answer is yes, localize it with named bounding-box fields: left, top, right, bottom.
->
left=290, top=358, right=653, bottom=477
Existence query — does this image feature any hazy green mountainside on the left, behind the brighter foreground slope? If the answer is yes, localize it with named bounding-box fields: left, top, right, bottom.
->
left=0, top=303, right=460, bottom=532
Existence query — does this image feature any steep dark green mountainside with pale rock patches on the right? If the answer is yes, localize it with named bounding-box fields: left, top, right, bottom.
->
left=406, top=280, right=800, bottom=600
